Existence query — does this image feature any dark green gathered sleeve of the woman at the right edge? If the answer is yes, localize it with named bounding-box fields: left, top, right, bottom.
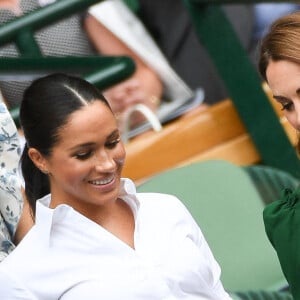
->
left=263, top=188, right=300, bottom=299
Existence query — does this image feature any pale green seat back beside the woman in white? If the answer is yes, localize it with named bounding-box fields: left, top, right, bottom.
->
left=138, top=161, right=286, bottom=291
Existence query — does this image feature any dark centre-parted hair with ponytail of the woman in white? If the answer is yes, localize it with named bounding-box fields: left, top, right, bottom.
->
left=20, top=74, right=109, bottom=213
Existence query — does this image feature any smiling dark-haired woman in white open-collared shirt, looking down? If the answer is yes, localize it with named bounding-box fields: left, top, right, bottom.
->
left=0, top=74, right=230, bottom=300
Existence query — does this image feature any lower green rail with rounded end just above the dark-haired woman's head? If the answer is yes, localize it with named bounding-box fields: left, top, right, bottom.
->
left=0, top=56, right=135, bottom=127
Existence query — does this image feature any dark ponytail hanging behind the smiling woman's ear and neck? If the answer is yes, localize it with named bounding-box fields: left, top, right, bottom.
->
left=21, top=143, right=50, bottom=216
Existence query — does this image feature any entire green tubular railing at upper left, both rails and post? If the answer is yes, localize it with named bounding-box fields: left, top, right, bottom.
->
left=0, top=0, right=135, bottom=126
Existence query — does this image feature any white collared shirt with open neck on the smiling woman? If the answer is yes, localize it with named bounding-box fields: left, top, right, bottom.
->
left=0, top=179, right=230, bottom=300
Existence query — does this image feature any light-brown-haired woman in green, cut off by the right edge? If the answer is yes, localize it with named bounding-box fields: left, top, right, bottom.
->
left=259, top=12, right=300, bottom=300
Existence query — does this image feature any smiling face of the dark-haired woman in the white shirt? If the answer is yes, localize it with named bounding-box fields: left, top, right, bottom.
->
left=40, top=101, right=125, bottom=215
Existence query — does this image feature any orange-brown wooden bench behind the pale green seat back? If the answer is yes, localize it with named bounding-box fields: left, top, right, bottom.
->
left=123, top=94, right=297, bottom=183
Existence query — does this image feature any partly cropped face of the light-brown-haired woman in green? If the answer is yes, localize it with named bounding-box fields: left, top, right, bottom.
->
left=266, top=60, right=300, bottom=130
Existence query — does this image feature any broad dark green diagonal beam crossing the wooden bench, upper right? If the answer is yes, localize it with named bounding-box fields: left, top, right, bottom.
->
left=184, top=0, right=300, bottom=177
